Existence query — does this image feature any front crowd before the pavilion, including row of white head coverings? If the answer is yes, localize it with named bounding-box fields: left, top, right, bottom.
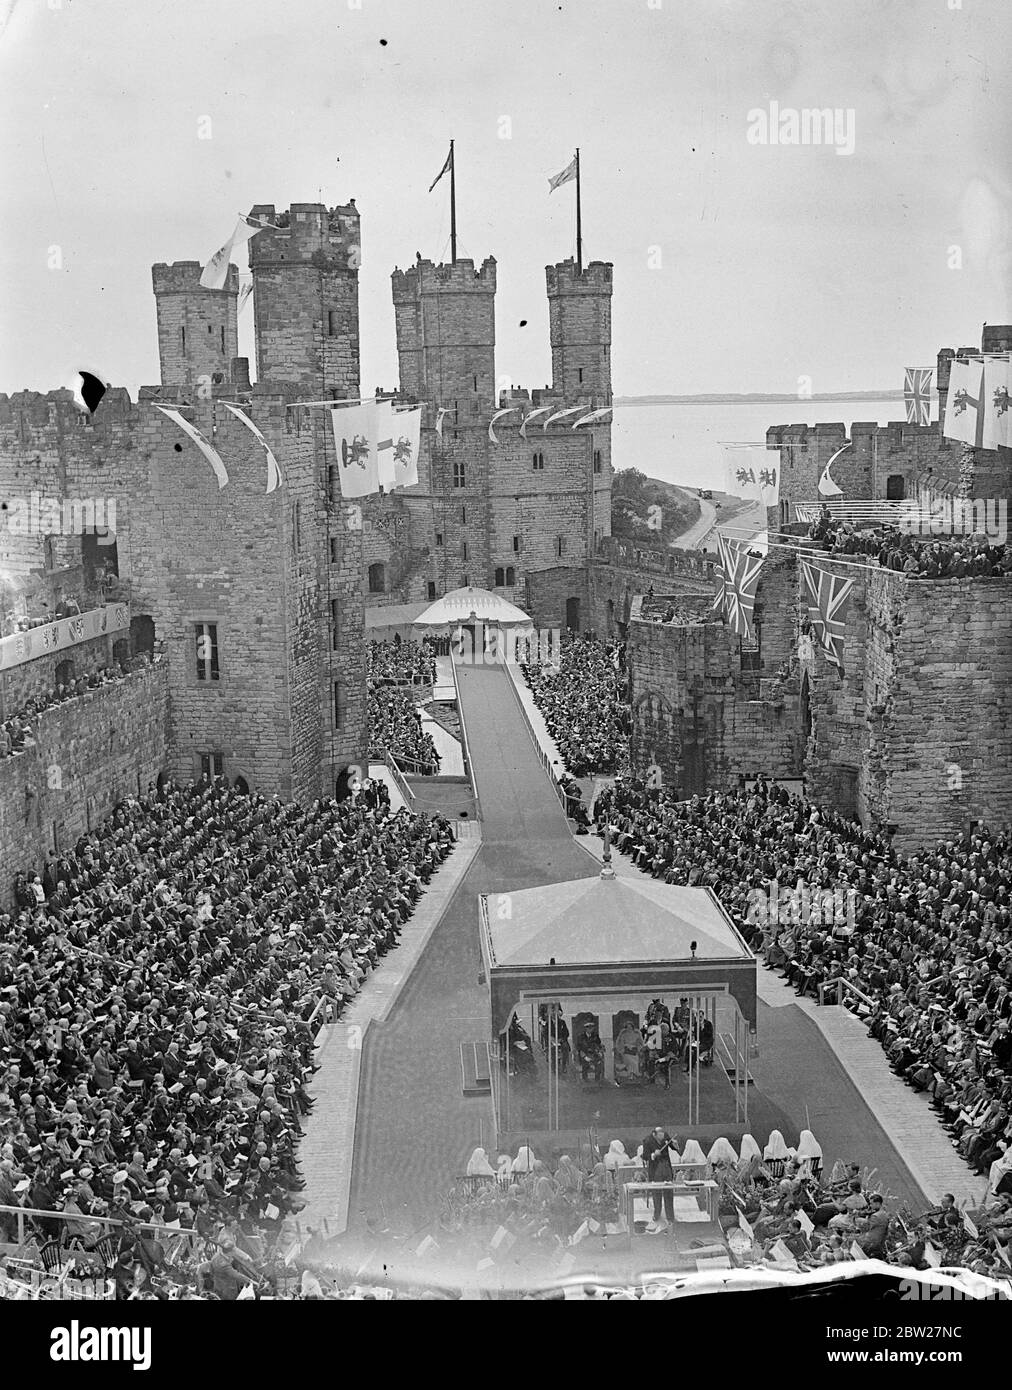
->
left=442, top=1130, right=1012, bottom=1280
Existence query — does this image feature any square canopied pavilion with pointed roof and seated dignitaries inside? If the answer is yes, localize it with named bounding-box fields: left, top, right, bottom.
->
left=478, top=863, right=758, bottom=1156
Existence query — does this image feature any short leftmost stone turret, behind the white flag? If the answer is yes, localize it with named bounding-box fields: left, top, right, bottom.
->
left=152, top=261, right=239, bottom=386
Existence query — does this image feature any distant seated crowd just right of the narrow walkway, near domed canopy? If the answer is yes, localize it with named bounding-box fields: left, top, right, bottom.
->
left=521, top=632, right=630, bottom=777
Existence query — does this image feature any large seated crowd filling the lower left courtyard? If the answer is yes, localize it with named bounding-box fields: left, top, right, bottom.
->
left=0, top=780, right=453, bottom=1297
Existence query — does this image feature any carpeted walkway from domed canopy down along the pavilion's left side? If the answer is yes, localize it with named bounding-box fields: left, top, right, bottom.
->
left=349, top=666, right=598, bottom=1230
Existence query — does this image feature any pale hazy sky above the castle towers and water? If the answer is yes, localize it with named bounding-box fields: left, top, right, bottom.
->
left=0, top=0, right=1012, bottom=395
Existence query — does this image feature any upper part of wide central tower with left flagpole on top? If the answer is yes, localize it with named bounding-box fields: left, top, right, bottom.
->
left=391, top=256, right=495, bottom=424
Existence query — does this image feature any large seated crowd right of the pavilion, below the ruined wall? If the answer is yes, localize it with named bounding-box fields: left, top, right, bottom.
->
left=595, top=778, right=1012, bottom=1175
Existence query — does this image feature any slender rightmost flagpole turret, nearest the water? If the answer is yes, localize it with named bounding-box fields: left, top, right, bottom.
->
left=545, top=259, right=612, bottom=404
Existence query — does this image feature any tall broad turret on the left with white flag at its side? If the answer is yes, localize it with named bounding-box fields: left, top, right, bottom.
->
left=249, top=199, right=361, bottom=400
